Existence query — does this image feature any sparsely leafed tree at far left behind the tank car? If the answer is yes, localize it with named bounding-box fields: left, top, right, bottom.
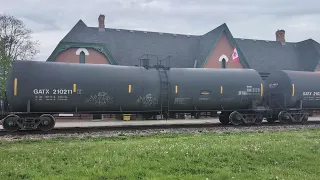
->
left=0, top=14, right=39, bottom=99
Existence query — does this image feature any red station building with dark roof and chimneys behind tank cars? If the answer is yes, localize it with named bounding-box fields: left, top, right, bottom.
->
left=47, top=15, right=320, bottom=120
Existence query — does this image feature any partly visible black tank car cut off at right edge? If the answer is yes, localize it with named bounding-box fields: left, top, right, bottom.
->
left=264, top=70, right=320, bottom=123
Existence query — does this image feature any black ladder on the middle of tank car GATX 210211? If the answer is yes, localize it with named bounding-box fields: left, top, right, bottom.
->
left=158, top=67, right=169, bottom=119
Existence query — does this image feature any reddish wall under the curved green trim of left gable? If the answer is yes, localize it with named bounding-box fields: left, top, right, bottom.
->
left=56, top=48, right=109, bottom=64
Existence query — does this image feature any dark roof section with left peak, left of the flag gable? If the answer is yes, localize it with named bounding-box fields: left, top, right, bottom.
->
left=61, top=21, right=200, bottom=67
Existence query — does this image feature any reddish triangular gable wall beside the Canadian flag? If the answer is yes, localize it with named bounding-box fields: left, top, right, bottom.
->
left=204, top=33, right=243, bottom=69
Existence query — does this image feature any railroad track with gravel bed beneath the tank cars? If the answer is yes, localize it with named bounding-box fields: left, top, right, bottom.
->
left=0, top=121, right=320, bottom=137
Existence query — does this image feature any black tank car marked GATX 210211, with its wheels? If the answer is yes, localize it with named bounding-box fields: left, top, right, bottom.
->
left=2, top=61, right=265, bottom=131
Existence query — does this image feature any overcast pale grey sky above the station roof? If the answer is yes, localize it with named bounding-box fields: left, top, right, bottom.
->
left=0, top=0, right=320, bottom=61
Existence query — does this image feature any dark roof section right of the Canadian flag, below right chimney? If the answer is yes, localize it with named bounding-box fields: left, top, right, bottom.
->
left=236, top=38, right=320, bottom=72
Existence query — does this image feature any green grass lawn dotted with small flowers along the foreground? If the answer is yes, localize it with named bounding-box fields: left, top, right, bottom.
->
left=0, top=130, right=320, bottom=180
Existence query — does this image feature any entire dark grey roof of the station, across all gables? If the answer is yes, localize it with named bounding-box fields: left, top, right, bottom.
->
left=48, top=20, right=320, bottom=73
